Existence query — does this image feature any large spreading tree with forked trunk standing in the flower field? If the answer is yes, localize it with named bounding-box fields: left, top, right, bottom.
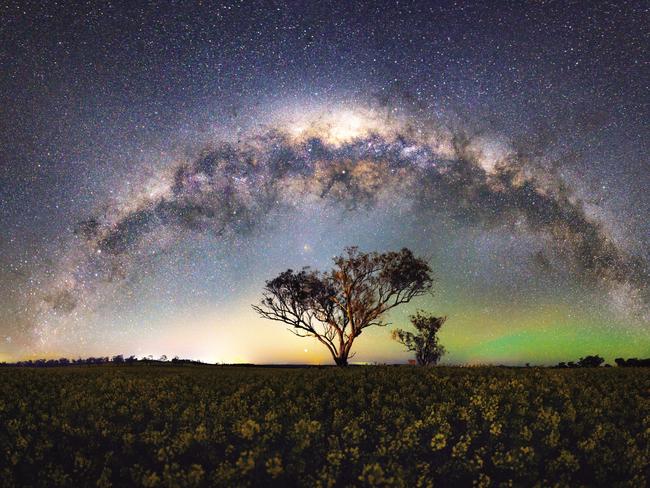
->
left=253, top=247, right=433, bottom=366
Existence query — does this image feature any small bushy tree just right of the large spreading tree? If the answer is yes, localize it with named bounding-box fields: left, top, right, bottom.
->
left=392, top=311, right=447, bottom=366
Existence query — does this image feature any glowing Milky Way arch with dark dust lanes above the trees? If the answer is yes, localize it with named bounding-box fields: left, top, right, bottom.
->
left=39, top=107, right=650, bottom=344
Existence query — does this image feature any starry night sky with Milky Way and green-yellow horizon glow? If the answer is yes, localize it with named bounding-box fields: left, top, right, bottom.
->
left=0, top=1, right=650, bottom=364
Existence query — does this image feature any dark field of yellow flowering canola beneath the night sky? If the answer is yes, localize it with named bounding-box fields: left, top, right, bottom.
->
left=0, top=365, right=650, bottom=487
